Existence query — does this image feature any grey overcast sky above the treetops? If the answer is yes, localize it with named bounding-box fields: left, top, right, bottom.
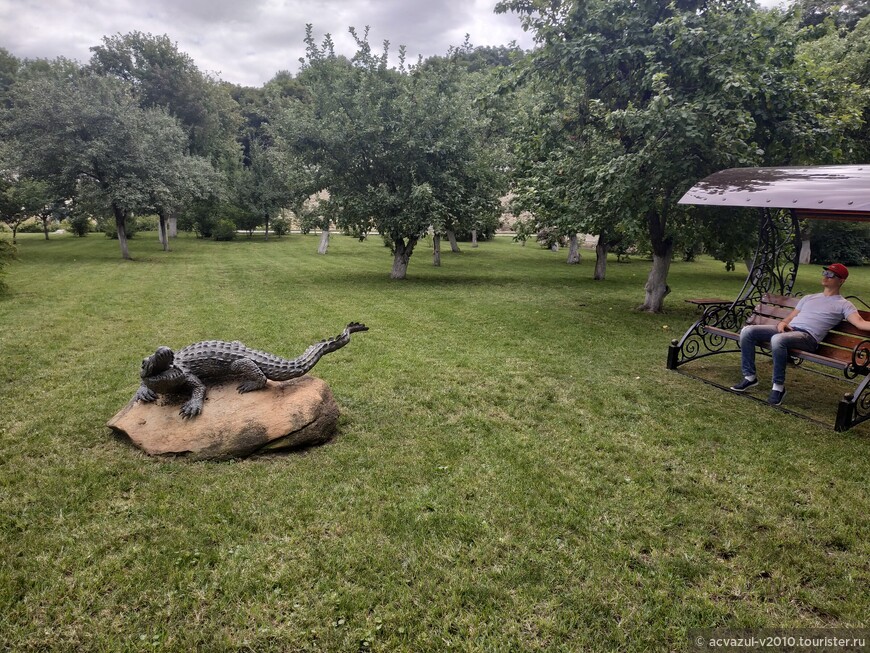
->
left=0, top=0, right=544, bottom=86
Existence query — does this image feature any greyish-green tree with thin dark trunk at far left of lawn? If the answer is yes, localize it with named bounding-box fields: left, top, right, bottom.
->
left=8, top=62, right=211, bottom=258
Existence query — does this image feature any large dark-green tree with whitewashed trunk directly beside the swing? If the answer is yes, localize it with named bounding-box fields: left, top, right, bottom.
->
left=497, top=0, right=860, bottom=311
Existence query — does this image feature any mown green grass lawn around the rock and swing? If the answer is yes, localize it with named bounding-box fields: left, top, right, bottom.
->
left=0, top=229, right=870, bottom=652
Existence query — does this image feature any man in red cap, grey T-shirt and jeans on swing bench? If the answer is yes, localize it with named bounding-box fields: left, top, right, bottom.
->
left=731, top=263, right=870, bottom=406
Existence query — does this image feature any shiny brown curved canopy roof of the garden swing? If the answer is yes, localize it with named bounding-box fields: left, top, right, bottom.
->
left=678, top=164, right=870, bottom=221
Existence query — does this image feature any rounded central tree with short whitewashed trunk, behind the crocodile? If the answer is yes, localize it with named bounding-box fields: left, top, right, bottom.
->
left=278, top=26, right=502, bottom=278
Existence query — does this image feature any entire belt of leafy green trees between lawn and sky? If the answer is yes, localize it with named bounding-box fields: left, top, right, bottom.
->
left=0, top=12, right=870, bottom=292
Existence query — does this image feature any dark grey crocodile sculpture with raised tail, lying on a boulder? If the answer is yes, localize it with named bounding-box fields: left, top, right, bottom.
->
left=134, top=322, right=368, bottom=417
